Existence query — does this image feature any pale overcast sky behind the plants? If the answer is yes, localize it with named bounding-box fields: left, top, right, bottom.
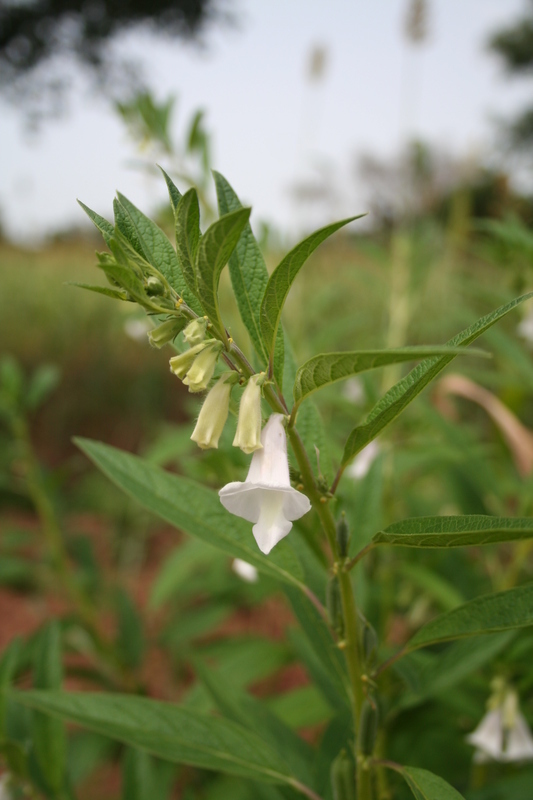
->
left=0, top=0, right=531, bottom=240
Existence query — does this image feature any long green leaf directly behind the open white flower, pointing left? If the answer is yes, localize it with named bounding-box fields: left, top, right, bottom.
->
left=75, top=439, right=304, bottom=589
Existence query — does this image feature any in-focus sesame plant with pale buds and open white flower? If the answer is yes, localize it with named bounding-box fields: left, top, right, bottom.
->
left=6, top=173, right=533, bottom=800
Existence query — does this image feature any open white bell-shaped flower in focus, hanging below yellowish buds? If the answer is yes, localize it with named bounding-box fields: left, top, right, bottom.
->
left=218, top=414, right=311, bottom=554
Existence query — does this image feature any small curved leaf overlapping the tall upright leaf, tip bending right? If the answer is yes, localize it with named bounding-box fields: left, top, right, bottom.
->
left=197, top=208, right=251, bottom=334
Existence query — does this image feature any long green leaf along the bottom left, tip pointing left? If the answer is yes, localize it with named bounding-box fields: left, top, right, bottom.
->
left=13, top=691, right=300, bottom=785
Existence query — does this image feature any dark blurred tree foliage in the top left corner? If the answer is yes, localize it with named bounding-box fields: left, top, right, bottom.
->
left=0, top=0, right=228, bottom=119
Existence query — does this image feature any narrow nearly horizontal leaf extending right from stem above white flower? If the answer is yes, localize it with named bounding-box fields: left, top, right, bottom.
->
left=294, top=345, right=488, bottom=405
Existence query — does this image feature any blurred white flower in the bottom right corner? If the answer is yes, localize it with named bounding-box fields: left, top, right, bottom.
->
left=466, top=678, right=533, bottom=764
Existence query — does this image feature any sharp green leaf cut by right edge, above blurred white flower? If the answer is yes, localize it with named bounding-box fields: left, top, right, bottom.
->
left=404, top=583, right=533, bottom=653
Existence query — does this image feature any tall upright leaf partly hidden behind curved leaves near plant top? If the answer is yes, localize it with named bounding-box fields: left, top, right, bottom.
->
left=213, top=171, right=284, bottom=388
